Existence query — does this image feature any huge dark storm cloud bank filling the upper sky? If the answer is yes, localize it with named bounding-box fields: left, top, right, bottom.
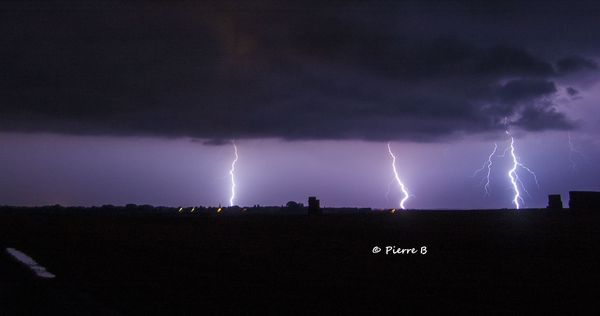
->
left=0, top=2, right=600, bottom=145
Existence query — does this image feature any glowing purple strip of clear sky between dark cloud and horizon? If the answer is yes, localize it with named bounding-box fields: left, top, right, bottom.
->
left=0, top=79, right=600, bottom=208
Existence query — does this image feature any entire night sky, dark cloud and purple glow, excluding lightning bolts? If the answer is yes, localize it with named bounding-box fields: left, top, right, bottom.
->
left=0, top=1, right=600, bottom=209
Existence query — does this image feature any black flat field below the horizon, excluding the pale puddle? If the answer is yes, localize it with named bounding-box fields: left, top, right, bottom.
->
left=0, top=210, right=600, bottom=315
